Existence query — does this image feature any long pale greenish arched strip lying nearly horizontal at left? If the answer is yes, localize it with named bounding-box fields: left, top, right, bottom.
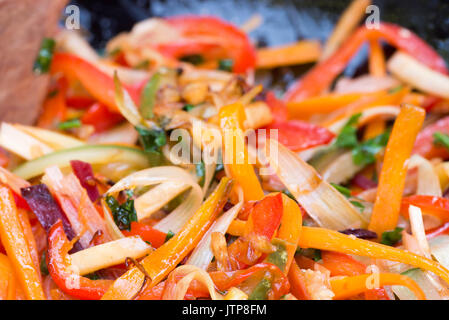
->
left=13, top=145, right=157, bottom=179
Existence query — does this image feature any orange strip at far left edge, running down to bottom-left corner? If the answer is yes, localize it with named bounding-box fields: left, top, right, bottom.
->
left=0, top=186, right=45, bottom=300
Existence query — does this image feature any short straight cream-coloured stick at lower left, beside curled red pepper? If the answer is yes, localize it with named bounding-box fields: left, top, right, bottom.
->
left=70, top=236, right=152, bottom=275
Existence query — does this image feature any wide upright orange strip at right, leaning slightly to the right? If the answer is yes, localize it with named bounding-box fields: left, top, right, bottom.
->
left=368, top=105, right=426, bottom=236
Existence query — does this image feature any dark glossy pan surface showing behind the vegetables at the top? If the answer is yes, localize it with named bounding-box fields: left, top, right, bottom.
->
left=68, top=0, right=449, bottom=89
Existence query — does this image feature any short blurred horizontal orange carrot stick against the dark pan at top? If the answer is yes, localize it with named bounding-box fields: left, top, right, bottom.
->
left=257, top=40, right=321, bottom=69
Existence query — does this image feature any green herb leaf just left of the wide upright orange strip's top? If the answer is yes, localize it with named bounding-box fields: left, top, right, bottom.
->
left=352, top=131, right=390, bottom=166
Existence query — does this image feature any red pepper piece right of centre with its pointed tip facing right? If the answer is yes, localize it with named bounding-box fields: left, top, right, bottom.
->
left=265, top=120, right=335, bottom=151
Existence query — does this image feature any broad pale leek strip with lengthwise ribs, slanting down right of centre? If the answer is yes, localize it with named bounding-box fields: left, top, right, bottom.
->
left=268, top=139, right=367, bottom=230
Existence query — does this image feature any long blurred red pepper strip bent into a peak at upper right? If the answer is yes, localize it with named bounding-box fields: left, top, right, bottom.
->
left=285, top=22, right=448, bottom=101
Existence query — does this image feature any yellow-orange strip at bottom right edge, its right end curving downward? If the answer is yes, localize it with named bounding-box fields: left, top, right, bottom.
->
left=330, top=273, right=426, bottom=300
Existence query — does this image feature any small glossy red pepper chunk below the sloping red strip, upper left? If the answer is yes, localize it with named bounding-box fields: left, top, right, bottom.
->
left=81, top=103, right=123, bottom=132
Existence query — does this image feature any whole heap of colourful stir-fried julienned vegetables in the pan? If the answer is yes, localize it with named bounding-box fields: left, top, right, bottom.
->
left=4, top=0, right=449, bottom=300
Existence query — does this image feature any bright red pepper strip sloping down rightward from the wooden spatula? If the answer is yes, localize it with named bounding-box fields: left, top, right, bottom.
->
left=50, top=53, right=139, bottom=112
